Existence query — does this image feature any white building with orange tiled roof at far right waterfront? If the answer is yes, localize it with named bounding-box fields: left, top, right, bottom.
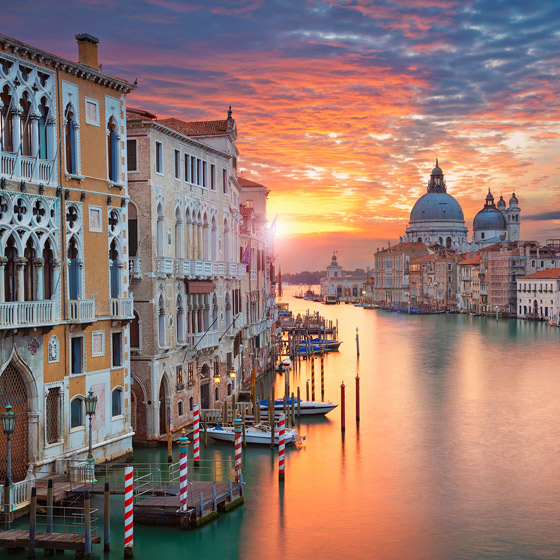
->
left=517, top=268, right=560, bottom=324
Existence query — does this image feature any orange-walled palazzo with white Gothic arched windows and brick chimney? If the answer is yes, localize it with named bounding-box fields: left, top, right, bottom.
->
left=0, top=34, right=133, bottom=482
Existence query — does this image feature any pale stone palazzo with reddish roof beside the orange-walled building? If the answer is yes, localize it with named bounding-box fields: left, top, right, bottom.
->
left=127, top=109, right=246, bottom=442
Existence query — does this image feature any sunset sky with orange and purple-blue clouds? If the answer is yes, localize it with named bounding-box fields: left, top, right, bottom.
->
left=5, top=0, right=560, bottom=272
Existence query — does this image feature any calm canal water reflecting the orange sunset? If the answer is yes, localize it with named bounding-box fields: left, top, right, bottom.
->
left=12, top=288, right=560, bottom=560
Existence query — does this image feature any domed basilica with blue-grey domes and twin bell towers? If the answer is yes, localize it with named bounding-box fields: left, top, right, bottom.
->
left=404, top=159, right=521, bottom=252
